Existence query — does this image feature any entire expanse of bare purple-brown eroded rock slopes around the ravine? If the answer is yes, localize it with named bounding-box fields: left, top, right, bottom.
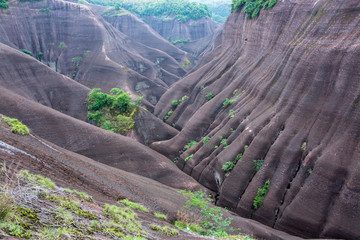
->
left=0, top=0, right=360, bottom=239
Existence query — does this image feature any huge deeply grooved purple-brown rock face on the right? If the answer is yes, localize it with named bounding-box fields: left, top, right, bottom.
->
left=152, top=0, right=360, bottom=239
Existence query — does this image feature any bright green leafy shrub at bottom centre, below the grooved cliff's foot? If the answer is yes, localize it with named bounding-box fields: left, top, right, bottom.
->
left=180, top=190, right=233, bottom=237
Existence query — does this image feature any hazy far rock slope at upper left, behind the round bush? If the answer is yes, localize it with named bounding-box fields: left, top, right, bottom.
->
left=0, top=0, right=191, bottom=109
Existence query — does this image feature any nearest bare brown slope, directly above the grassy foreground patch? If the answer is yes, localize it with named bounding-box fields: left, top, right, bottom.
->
left=0, top=118, right=300, bottom=240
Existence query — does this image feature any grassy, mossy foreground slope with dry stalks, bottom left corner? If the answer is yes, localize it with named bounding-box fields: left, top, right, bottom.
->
left=0, top=165, right=148, bottom=240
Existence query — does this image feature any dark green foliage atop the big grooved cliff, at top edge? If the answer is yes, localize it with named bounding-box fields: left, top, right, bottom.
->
left=231, top=0, right=277, bottom=18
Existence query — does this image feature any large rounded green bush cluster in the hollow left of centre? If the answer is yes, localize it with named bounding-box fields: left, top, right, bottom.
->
left=86, top=88, right=138, bottom=134
